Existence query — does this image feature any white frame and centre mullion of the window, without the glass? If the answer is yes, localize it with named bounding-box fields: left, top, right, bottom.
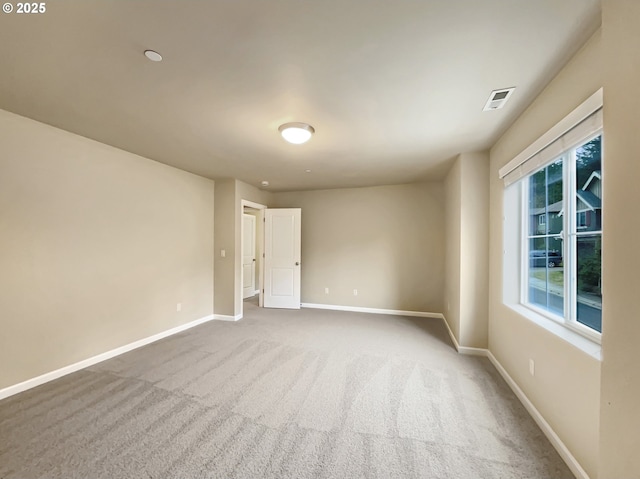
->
left=519, top=134, right=604, bottom=344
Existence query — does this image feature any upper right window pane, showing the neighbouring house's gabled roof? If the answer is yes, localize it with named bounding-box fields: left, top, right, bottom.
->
left=575, top=136, right=602, bottom=231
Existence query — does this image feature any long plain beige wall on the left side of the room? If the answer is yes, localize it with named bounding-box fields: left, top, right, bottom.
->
left=0, top=110, right=214, bottom=388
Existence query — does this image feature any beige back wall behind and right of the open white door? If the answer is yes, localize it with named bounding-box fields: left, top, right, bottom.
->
left=274, top=183, right=445, bottom=312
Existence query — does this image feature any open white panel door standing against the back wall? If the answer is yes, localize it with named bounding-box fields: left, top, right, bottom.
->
left=264, top=208, right=302, bottom=309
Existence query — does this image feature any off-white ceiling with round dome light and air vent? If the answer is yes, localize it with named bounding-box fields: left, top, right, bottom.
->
left=0, top=0, right=600, bottom=191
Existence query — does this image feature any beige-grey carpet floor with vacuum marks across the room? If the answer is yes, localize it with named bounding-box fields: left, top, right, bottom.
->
left=0, top=302, right=573, bottom=479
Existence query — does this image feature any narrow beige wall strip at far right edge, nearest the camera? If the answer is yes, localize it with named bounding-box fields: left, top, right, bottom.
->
left=599, top=0, right=640, bottom=479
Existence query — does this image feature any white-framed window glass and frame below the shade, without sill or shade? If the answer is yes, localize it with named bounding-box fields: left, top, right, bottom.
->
left=522, top=135, right=602, bottom=333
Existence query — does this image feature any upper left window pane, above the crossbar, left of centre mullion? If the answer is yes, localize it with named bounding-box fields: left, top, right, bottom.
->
left=529, top=159, right=563, bottom=236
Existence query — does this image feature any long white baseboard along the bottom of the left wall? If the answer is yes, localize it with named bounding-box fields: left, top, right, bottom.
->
left=0, top=314, right=214, bottom=399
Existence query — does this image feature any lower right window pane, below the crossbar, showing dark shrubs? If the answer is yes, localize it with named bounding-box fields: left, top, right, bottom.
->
left=576, top=235, right=602, bottom=332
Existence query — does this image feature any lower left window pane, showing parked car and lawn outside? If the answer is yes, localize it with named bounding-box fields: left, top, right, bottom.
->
left=528, top=238, right=564, bottom=316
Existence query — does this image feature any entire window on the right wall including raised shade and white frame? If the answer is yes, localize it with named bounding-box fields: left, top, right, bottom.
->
left=500, top=90, right=603, bottom=342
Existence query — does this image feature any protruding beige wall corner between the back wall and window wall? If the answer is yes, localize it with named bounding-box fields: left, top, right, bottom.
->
left=445, top=153, right=489, bottom=348
